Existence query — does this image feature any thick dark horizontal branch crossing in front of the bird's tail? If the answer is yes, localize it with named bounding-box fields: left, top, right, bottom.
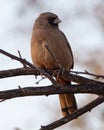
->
left=0, top=84, right=104, bottom=99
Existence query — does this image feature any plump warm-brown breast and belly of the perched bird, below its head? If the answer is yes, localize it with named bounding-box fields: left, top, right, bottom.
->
left=31, top=28, right=73, bottom=69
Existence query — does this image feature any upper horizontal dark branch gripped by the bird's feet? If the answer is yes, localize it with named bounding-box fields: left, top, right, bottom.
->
left=0, top=67, right=103, bottom=85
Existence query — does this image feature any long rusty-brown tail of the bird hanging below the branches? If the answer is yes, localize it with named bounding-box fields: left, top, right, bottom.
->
left=57, top=78, right=77, bottom=116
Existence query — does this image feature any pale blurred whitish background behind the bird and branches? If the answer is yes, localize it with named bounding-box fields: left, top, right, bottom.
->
left=0, top=0, right=104, bottom=130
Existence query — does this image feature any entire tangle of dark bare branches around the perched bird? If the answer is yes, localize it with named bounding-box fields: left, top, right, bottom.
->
left=0, top=49, right=104, bottom=130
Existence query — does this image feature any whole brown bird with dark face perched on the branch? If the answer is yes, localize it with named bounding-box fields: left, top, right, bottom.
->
left=31, top=12, right=77, bottom=116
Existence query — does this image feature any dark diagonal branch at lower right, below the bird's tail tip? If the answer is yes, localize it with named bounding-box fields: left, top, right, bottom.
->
left=40, top=96, right=104, bottom=130
